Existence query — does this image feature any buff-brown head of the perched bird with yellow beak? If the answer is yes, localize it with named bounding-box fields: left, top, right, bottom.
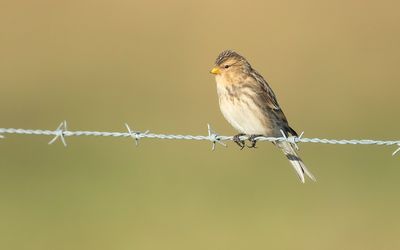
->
left=210, top=50, right=251, bottom=81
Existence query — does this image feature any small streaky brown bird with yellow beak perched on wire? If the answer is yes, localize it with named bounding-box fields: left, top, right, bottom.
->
left=211, top=50, right=315, bottom=183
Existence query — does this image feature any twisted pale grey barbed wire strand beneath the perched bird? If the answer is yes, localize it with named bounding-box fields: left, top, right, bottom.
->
left=0, top=121, right=400, bottom=156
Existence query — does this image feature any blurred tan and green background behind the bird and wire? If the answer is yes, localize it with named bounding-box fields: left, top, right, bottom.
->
left=0, top=0, right=400, bottom=250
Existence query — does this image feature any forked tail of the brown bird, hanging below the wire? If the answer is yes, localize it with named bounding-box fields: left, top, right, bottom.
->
left=276, top=141, right=316, bottom=183
